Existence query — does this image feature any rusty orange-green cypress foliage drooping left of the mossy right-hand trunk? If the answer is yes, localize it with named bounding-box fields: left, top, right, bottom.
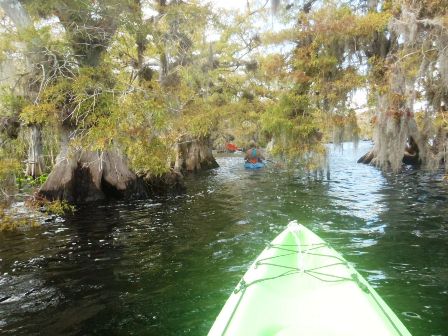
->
left=261, top=1, right=392, bottom=164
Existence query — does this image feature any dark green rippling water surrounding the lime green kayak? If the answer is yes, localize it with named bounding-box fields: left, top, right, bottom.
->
left=0, top=143, right=448, bottom=335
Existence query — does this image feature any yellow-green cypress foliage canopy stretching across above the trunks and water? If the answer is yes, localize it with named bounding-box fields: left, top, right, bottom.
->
left=7, top=0, right=438, bottom=184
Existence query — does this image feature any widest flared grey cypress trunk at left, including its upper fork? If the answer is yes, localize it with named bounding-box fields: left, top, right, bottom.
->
left=38, top=9, right=148, bottom=204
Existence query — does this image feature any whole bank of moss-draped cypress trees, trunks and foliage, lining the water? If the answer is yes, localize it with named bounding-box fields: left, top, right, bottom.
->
left=0, top=0, right=448, bottom=229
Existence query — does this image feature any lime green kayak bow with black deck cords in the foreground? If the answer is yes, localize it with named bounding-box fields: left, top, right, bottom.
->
left=208, top=222, right=411, bottom=336
